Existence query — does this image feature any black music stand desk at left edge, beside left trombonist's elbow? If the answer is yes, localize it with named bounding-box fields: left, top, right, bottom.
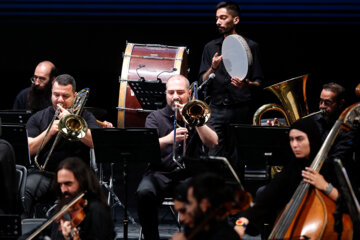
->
left=1, top=125, right=31, bottom=167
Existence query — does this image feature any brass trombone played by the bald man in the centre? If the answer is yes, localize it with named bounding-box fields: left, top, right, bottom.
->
left=172, top=81, right=211, bottom=169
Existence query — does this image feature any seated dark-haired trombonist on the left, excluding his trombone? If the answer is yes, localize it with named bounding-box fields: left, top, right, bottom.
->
left=25, top=74, right=99, bottom=217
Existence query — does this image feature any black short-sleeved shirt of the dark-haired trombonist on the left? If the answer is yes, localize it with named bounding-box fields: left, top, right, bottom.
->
left=26, top=106, right=99, bottom=171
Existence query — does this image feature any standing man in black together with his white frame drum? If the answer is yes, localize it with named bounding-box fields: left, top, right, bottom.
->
left=199, top=2, right=263, bottom=171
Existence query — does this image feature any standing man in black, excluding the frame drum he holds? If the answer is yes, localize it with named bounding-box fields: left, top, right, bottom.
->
left=199, top=2, right=263, bottom=171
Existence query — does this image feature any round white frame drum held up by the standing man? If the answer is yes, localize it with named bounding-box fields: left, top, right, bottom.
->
left=221, top=34, right=252, bottom=79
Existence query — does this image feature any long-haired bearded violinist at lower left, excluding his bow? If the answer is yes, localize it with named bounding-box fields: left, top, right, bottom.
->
left=51, top=157, right=115, bottom=240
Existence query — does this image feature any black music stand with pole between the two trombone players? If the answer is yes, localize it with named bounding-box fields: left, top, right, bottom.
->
left=91, top=128, right=160, bottom=240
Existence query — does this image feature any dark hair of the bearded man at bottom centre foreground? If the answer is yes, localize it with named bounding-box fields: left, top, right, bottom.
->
left=189, top=173, right=234, bottom=209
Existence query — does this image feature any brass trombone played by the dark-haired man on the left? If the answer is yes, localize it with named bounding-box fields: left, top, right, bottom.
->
left=34, top=88, right=90, bottom=171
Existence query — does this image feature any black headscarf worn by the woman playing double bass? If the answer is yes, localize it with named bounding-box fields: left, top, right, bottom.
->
left=290, top=118, right=322, bottom=161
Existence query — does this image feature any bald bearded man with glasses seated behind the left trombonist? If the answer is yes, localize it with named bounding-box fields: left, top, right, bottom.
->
left=13, top=61, right=56, bottom=113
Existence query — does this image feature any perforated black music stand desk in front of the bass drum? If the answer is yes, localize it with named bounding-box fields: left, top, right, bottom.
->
left=127, top=80, right=166, bottom=110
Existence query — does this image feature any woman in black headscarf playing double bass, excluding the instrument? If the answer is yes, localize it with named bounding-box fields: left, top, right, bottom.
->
left=235, top=118, right=339, bottom=237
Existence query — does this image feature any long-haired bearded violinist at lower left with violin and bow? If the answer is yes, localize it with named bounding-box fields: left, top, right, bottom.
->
left=20, top=157, right=115, bottom=240
